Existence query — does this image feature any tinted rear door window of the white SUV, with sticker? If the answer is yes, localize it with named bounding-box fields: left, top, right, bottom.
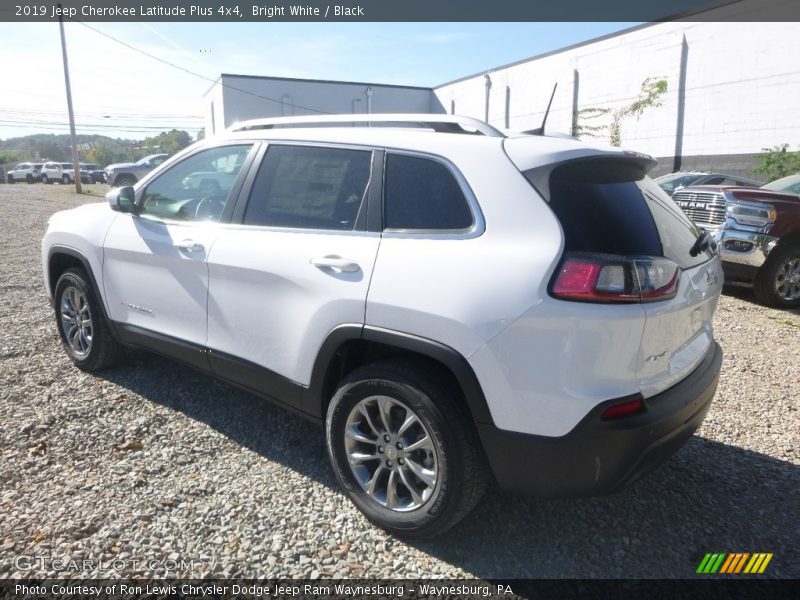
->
left=244, top=145, right=372, bottom=231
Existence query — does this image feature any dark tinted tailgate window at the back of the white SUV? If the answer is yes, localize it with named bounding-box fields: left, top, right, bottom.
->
left=526, top=158, right=711, bottom=268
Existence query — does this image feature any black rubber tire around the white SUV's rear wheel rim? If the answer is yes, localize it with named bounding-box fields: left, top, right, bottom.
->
left=326, top=359, right=489, bottom=539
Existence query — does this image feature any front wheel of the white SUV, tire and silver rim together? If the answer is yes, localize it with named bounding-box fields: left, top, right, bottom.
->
left=55, top=269, right=122, bottom=371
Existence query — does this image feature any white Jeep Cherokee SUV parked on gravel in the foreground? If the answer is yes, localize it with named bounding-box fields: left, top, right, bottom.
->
left=42, top=115, right=722, bottom=537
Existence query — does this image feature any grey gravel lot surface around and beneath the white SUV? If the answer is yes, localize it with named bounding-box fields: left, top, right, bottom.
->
left=0, top=185, right=800, bottom=578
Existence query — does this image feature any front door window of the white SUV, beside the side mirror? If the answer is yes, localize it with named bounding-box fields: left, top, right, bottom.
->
left=139, top=144, right=253, bottom=221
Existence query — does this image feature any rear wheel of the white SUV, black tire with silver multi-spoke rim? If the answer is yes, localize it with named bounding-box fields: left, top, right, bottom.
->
left=326, top=360, right=488, bottom=538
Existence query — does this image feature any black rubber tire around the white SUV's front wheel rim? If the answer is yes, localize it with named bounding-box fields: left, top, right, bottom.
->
left=54, top=268, right=123, bottom=372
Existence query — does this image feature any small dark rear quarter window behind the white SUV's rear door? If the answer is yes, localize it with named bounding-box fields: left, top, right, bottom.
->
left=384, top=154, right=473, bottom=230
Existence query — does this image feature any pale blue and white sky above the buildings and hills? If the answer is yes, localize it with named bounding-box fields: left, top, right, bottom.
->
left=0, top=22, right=636, bottom=139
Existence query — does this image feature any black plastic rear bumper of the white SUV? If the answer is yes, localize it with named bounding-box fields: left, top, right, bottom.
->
left=477, top=342, right=722, bottom=497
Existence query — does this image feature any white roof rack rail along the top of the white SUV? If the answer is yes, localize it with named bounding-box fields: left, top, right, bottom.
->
left=228, top=113, right=506, bottom=137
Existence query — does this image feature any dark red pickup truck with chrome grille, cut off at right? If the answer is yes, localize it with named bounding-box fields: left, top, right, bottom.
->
left=672, top=185, right=800, bottom=308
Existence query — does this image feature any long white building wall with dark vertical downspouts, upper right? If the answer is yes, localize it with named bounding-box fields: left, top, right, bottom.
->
left=435, top=22, right=800, bottom=162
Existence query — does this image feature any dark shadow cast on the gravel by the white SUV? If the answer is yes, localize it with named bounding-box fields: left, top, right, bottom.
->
left=97, top=353, right=800, bottom=579
